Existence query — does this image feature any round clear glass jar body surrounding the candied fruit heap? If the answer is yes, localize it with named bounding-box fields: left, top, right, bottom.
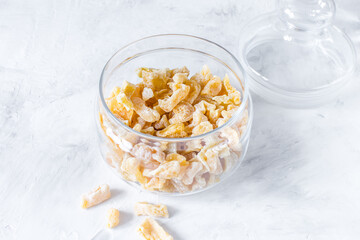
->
left=96, top=34, right=253, bottom=195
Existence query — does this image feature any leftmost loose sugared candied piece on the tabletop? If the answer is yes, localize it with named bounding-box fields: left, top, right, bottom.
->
left=81, top=184, right=111, bottom=208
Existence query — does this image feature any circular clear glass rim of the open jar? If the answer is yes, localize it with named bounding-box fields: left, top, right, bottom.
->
left=99, top=34, right=252, bottom=142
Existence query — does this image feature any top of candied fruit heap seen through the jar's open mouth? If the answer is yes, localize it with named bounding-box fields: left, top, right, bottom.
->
left=106, top=65, right=241, bottom=138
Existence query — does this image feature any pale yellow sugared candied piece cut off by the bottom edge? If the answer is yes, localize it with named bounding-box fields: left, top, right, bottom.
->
left=138, top=218, right=174, bottom=240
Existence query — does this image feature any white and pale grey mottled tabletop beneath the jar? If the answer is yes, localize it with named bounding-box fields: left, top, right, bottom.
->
left=0, top=0, right=360, bottom=240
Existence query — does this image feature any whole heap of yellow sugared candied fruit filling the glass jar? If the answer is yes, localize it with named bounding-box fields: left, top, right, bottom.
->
left=100, top=65, right=248, bottom=192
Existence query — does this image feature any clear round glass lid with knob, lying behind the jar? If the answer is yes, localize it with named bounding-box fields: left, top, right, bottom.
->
left=239, top=0, right=356, bottom=108
